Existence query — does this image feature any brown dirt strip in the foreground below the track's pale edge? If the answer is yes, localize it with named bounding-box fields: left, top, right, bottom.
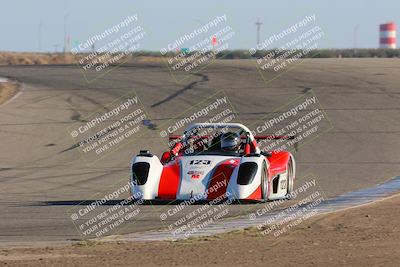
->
left=0, top=195, right=400, bottom=266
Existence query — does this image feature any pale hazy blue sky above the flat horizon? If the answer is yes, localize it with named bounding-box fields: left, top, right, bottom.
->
left=0, top=0, right=400, bottom=51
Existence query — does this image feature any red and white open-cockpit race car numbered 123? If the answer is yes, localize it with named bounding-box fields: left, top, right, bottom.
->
left=131, top=123, right=295, bottom=201
